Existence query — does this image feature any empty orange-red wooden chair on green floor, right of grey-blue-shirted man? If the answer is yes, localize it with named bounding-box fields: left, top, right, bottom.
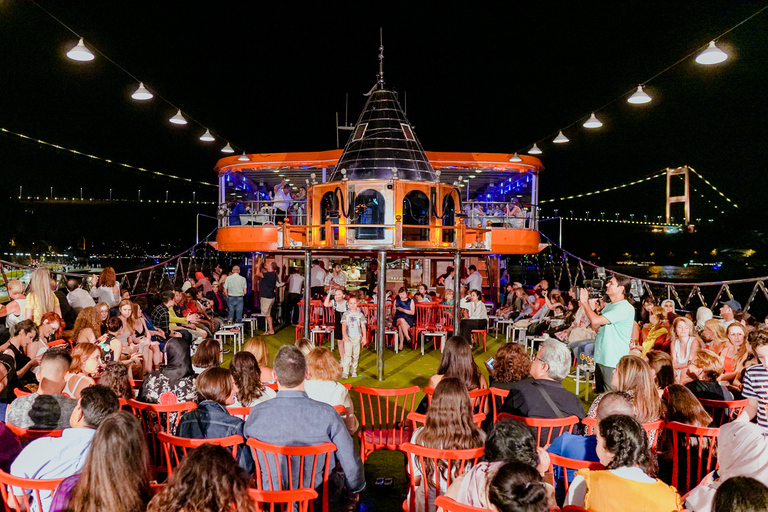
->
left=355, top=386, right=419, bottom=462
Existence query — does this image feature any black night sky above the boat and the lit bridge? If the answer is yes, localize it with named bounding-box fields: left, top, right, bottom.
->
left=0, top=0, right=768, bottom=256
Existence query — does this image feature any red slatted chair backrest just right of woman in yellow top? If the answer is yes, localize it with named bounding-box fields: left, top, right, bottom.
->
left=665, top=421, right=720, bottom=495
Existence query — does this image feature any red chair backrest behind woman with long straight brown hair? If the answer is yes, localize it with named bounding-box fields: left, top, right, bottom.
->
left=400, top=443, right=485, bottom=512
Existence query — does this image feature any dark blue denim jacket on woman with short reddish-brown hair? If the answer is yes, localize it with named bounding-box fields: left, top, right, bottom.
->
left=176, top=400, right=254, bottom=475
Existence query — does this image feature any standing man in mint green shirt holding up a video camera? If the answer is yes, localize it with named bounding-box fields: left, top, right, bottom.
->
left=579, top=276, right=635, bottom=393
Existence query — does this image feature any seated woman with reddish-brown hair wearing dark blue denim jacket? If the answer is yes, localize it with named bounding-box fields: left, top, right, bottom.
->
left=176, top=367, right=253, bottom=471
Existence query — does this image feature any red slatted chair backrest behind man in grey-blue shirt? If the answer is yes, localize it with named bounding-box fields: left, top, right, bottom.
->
left=246, top=437, right=336, bottom=512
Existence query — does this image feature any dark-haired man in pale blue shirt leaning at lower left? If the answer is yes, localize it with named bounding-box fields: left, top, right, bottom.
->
left=11, top=385, right=120, bottom=512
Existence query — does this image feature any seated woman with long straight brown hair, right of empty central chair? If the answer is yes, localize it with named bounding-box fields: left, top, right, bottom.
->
left=407, top=377, right=485, bottom=511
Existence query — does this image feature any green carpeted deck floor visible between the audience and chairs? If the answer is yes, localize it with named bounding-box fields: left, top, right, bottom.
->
left=231, top=326, right=594, bottom=512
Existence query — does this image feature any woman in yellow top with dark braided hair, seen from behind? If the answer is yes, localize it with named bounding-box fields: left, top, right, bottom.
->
left=565, top=414, right=682, bottom=512
